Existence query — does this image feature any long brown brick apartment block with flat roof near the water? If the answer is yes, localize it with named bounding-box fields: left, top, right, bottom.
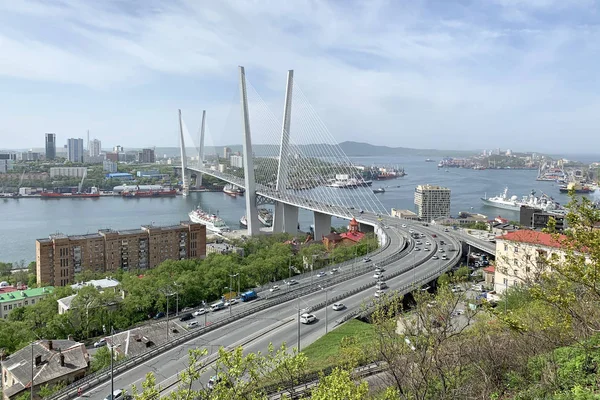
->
left=36, top=221, right=206, bottom=286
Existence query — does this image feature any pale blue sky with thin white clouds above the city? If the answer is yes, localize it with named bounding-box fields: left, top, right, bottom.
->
left=0, top=0, right=600, bottom=153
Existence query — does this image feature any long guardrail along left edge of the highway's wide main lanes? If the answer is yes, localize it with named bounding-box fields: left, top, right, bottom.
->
left=48, top=231, right=410, bottom=400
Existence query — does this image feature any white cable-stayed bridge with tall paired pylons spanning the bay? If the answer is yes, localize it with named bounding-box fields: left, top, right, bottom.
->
left=179, top=67, right=387, bottom=239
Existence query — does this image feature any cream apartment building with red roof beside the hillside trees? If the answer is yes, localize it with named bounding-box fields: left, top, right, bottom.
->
left=494, top=230, right=565, bottom=293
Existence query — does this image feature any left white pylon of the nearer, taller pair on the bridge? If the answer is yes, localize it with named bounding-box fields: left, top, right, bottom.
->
left=240, top=66, right=260, bottom=236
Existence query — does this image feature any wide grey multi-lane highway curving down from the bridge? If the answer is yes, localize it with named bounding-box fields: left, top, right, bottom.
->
left=84, top=222, right=459, bottom=399
